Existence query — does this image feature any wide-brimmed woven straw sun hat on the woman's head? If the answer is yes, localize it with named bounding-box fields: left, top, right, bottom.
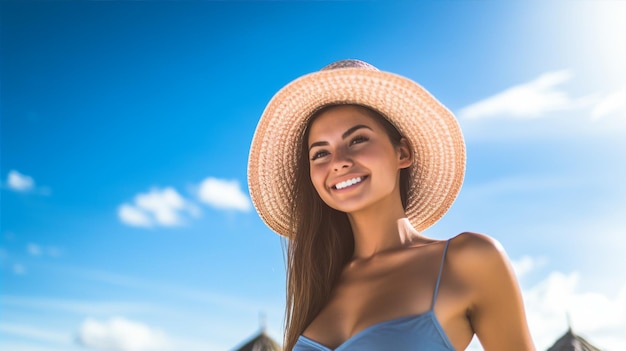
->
left=248, top=60, right=465, bottom=236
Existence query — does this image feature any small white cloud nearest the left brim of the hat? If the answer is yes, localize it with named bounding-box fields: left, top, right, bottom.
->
left=198, top=177, right=251, bottom=212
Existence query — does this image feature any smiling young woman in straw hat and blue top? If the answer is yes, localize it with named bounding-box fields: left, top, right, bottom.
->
left=248, top=60, right=534, bottom=351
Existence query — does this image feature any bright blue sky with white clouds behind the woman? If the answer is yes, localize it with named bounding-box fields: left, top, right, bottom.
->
left=0, top=0, right=626, bottom=351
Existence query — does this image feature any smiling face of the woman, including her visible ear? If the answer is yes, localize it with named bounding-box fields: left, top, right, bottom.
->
left=308, top=105, right=411, bottom=213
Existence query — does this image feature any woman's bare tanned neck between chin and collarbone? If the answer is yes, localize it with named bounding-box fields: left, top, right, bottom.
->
left=348, top=197, right=419, bottom=259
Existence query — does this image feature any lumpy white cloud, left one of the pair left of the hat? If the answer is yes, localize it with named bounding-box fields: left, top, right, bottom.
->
left=118, top=187, right=199, bottom=227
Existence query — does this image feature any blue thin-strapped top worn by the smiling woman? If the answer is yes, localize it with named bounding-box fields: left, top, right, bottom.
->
left=293, top=240, right=455, bottom=351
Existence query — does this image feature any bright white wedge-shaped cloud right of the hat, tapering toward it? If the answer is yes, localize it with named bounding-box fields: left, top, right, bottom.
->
left=459, top=70, right=591, bottom=119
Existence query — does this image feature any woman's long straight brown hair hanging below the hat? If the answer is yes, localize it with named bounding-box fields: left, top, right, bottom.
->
left=283, top=105, right=409, bottom=351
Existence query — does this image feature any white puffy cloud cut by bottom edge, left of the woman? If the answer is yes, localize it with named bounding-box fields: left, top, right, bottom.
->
left=77, top=317, right=168, bottom=351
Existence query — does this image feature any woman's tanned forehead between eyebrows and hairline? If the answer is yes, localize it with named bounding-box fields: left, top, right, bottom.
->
left=309, top=105, right=382, bottom=140
